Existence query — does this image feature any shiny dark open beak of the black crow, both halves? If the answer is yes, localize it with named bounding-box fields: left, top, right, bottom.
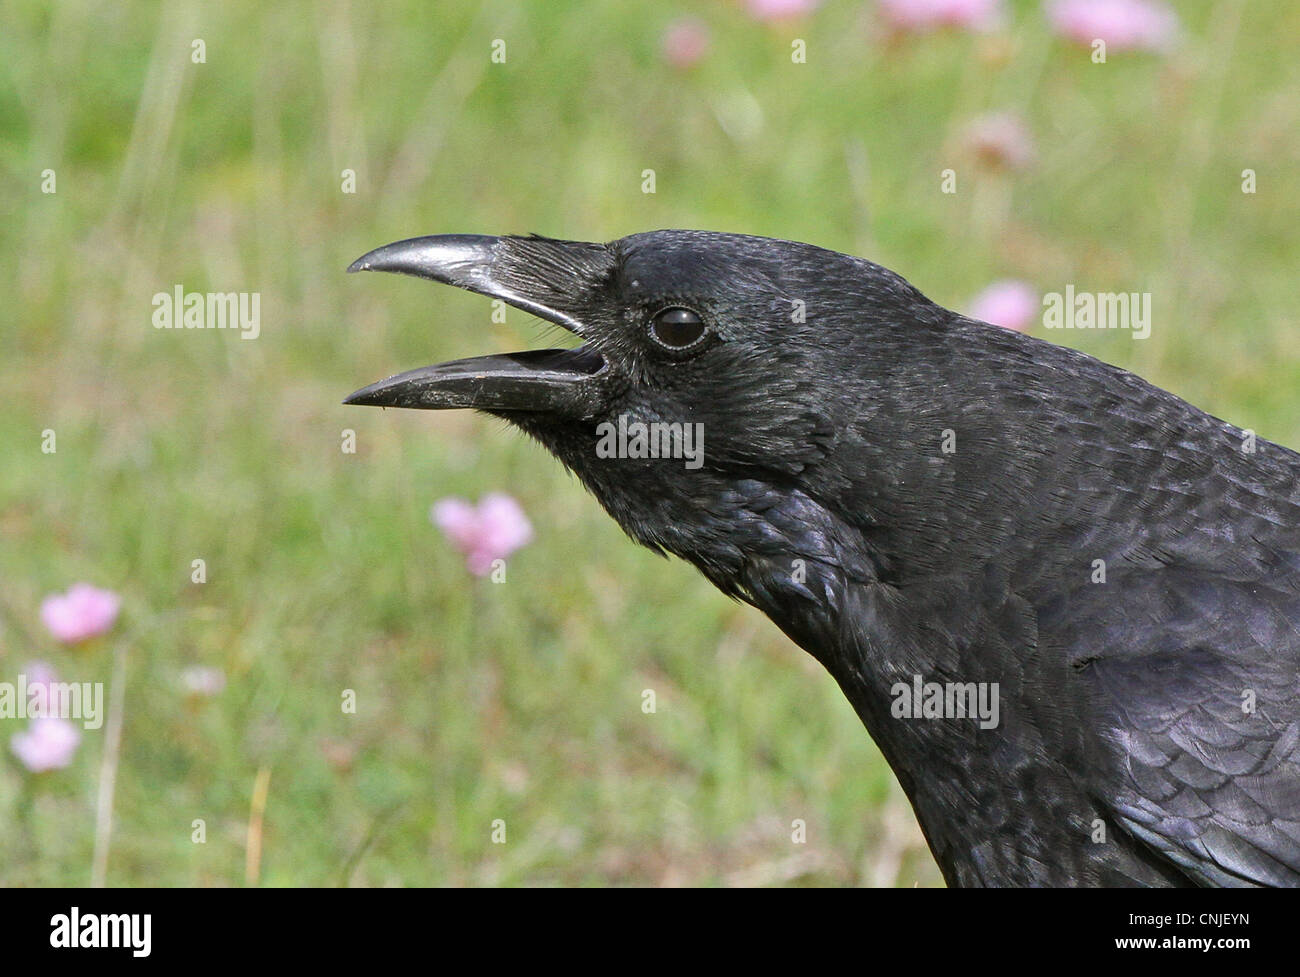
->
left=343, top=234, right=608, bottom=416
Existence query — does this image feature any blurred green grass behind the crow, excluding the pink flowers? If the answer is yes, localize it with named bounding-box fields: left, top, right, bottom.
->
left=0, top=0, right=1300, bottom=886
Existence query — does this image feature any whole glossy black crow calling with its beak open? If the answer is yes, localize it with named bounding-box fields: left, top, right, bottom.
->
left=345, top=230, right=1300, bottom=886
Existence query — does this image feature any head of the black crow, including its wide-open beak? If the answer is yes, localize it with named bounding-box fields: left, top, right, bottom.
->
left=346, top=230, right=953, bottom=599
